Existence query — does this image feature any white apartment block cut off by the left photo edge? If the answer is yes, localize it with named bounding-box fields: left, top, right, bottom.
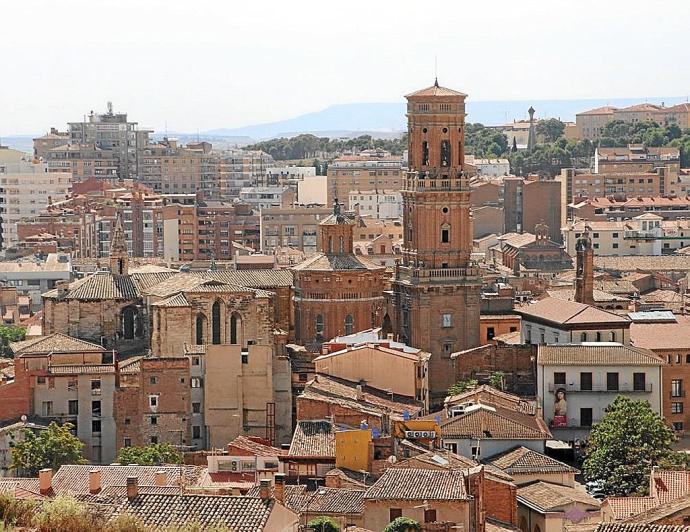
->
left=0, top=150, right=72, bottom=248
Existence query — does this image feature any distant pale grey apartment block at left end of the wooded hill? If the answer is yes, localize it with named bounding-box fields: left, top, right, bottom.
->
left=218, top=149, right=274, bottom=198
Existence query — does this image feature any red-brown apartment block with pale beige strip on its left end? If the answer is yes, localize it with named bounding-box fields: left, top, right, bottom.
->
left=163, top=199, right=260, bottom=261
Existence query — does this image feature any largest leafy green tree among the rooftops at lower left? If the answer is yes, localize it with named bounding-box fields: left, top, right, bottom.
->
left=12, top=422, right=86, bottom=476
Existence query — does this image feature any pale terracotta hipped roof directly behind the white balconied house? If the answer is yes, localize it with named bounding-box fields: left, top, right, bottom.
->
left=515, top=297, right=630, bottom=326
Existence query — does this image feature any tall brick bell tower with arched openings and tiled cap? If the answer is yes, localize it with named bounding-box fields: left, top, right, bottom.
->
left=388, top=82, right=481, bottom=403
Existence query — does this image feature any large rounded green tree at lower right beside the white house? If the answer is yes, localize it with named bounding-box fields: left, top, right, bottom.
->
left=583, top=395, right=686, bottom=496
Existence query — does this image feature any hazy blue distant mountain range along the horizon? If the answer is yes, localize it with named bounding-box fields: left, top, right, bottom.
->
left=0, top=96, right=686, bottom=152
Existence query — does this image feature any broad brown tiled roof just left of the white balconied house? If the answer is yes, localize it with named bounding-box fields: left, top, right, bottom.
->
left=441, top=404, right=551, bottom=440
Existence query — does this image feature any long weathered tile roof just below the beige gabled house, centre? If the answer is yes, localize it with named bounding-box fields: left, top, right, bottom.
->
left=297, top=375, right=424, bottom=420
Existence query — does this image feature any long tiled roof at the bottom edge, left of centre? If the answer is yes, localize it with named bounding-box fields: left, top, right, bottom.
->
left=114, top=494, right=274, bottom=532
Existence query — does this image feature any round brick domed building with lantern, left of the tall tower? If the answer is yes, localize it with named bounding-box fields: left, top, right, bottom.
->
left=293, top=202, right=387, bottom=348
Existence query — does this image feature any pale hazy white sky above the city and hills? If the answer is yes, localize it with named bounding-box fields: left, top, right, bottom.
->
left=0, top=0, right=690, bottom=135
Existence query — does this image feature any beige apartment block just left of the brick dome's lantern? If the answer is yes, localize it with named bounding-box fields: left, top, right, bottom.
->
left=261, top=206, right=333, bottom=254
